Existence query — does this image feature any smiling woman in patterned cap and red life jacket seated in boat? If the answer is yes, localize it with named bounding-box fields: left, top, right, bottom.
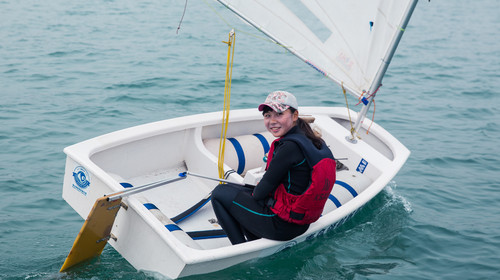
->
left=212, top=91, right=335, bottom=244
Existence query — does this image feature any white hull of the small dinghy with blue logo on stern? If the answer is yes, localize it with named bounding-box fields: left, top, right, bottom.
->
left=63, top=107, right=410, bottom=278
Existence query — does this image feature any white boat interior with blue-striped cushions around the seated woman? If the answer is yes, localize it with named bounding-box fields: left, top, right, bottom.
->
left=90, top=111, right=393, bottom=249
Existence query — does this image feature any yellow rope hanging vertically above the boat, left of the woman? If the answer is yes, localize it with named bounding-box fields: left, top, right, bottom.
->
left=217, top=29, right=236, bottom=179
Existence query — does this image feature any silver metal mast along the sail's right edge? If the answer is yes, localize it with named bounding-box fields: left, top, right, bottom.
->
left=346, top=0, right=418, bottom=143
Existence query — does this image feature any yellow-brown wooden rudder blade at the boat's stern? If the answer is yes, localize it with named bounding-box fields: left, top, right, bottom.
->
left=60, top=196, right=122, bottom=272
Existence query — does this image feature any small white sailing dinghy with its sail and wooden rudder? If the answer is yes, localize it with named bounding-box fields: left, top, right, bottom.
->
left=62, top=0, right=417, bottom=278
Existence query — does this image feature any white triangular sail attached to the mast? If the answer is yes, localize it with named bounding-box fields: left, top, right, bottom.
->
left=219, top=0, right=416, bottom=96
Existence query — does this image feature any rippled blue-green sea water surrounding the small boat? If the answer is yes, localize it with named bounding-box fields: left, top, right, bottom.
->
left=0, top=0, right=500, bottom=279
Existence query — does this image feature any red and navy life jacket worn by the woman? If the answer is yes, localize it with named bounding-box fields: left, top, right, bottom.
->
left=267, top=133, right=336, bottom=225
